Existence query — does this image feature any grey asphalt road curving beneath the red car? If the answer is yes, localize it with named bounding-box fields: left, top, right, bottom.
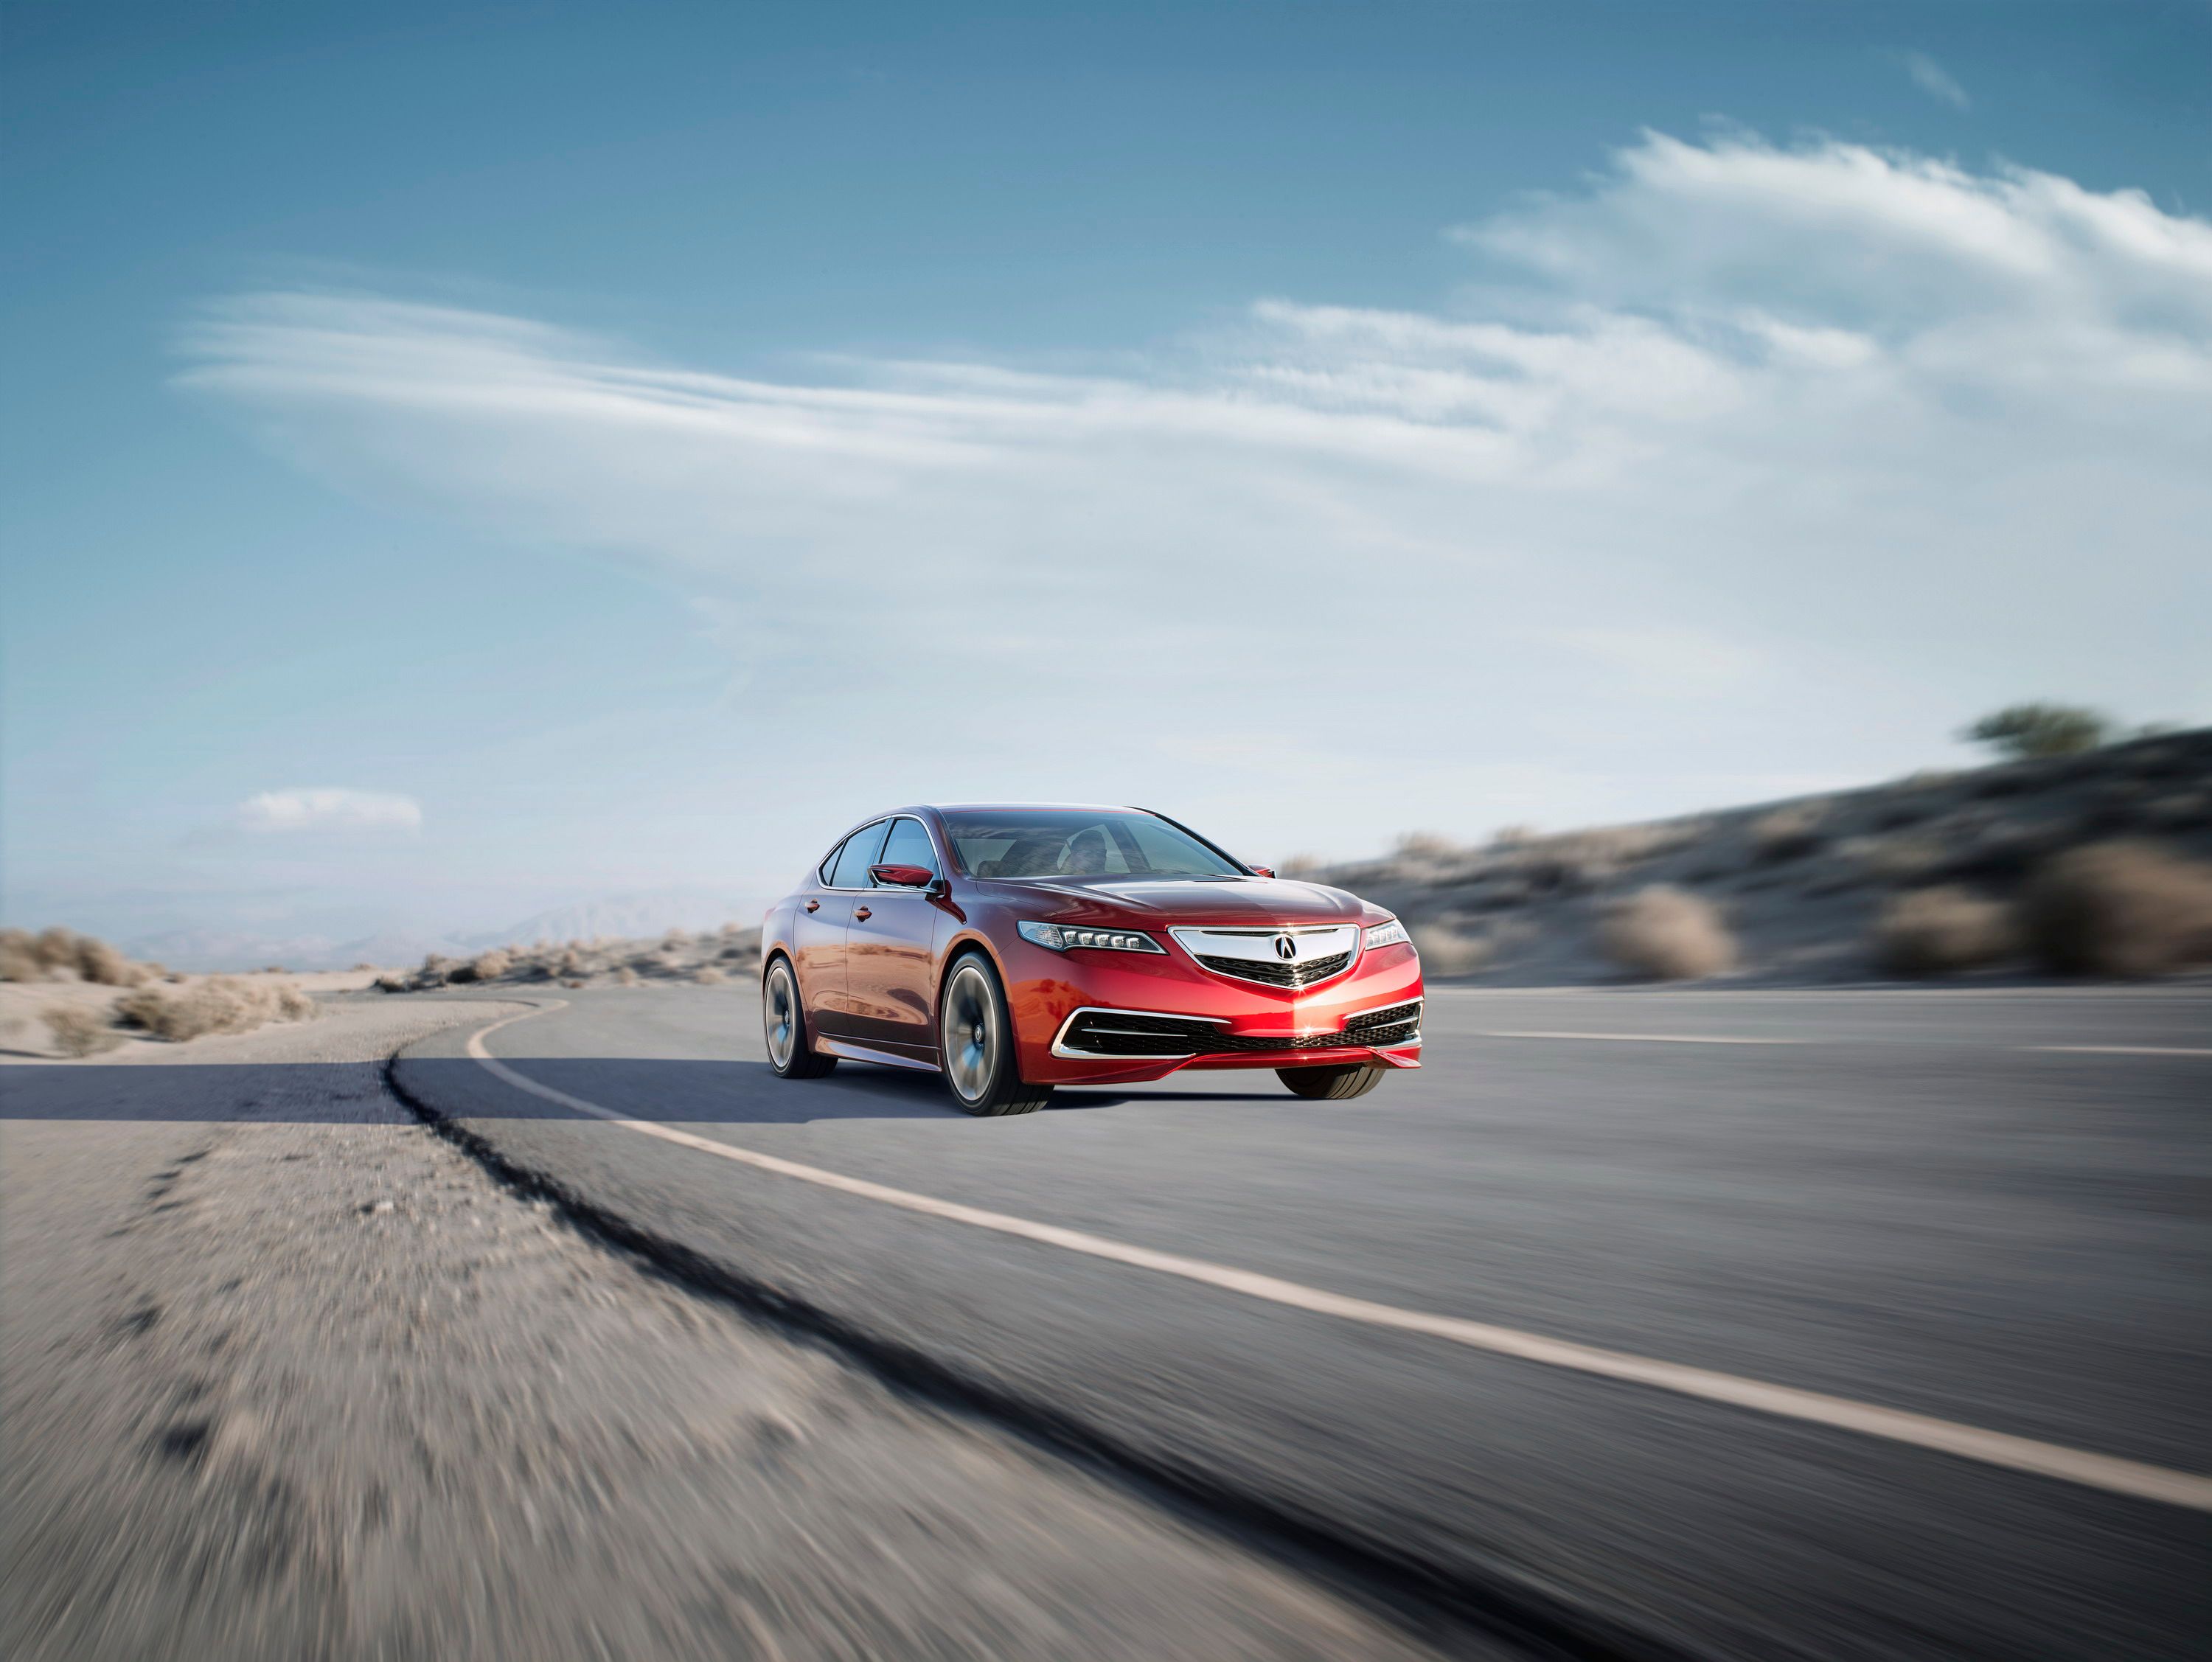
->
left=394, top=987, right=2212, bottom=1658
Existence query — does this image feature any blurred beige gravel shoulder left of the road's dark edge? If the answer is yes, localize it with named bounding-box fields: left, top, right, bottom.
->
left=0, top=1001, right=1471, bottom=1660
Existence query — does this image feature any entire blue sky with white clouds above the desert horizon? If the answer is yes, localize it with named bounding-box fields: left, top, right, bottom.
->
left=0, top=2, right=2212, bottom=960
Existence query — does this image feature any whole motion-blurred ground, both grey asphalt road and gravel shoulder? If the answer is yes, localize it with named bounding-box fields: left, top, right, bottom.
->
left=0, top=985, right=2212, bottom=1658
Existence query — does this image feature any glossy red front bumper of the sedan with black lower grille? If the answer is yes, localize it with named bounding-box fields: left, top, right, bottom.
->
left=1006, top=936, right=1422, bottom=1085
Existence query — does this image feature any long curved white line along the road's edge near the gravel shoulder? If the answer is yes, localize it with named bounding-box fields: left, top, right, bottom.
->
left=453, top=1005, right=2212, bottom=1512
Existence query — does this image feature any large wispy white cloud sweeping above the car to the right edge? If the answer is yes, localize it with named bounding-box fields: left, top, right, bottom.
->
left=184, top=133, right=2212, bottom=846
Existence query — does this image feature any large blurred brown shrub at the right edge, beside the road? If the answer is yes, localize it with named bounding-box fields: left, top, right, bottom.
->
left=2020, top=844, right=2212, bottom=976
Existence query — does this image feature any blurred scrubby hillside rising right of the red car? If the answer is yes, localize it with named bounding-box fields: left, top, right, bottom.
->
left=1296, top=728, right=2212, bottom=985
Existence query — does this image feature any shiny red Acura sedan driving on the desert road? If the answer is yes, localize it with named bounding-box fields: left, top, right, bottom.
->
left=761, top=805, right=1422, bottom=1113
